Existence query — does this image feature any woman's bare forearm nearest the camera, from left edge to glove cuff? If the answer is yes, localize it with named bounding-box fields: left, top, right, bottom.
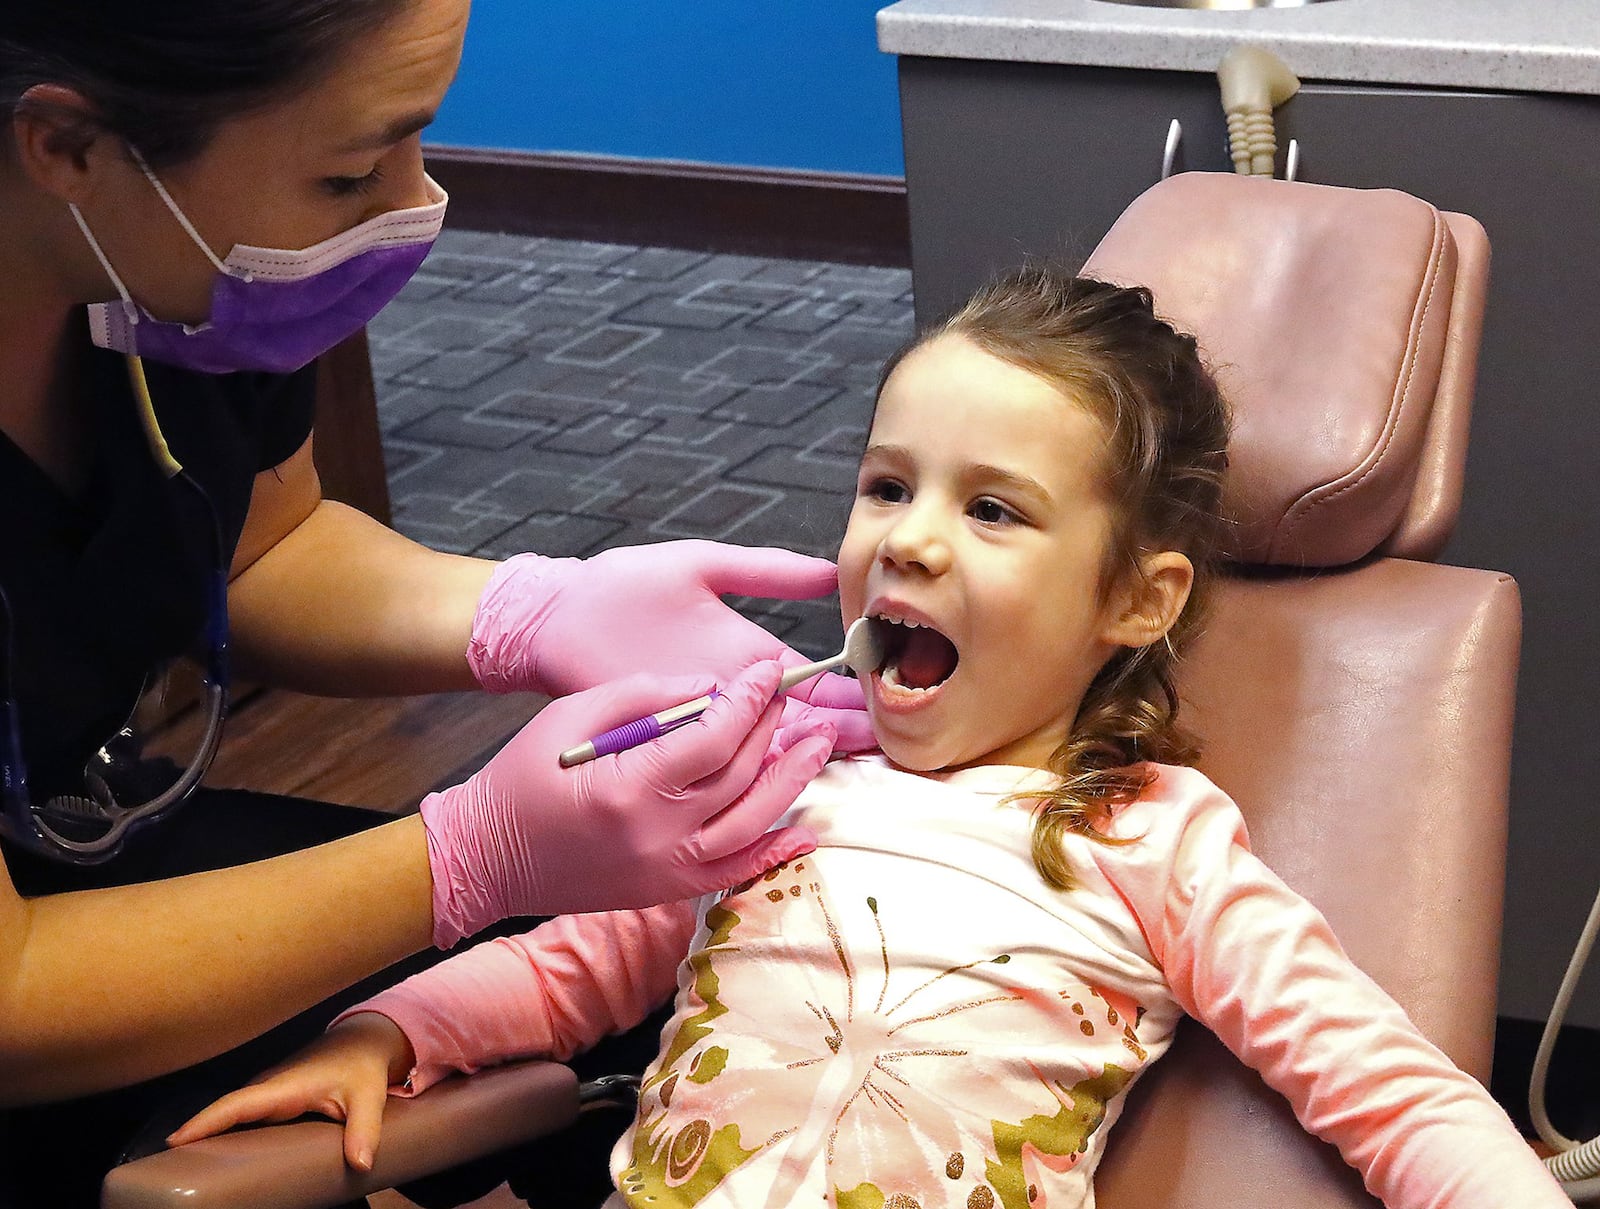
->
left=0, top=816, right=432, bottom=1103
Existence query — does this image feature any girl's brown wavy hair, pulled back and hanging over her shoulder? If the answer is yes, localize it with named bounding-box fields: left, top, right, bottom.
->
left=880, top=265, right=1229, bottom=888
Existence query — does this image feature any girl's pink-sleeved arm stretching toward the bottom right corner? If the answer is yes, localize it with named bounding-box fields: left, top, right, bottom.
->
left=1117, top=774, right=1571, bottom=1209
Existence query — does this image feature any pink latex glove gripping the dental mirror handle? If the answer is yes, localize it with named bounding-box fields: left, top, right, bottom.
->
left=422, top=660, right=834, bottom=948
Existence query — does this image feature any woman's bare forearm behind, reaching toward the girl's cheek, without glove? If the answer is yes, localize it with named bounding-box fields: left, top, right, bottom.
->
left=229, top=501, right=494, bottom=697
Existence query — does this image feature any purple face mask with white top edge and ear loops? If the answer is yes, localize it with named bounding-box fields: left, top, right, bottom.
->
left=72, top=152, right=450, bottom=374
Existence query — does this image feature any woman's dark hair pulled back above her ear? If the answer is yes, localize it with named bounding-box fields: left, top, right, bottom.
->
left=0, top=0, right=414, bottom=168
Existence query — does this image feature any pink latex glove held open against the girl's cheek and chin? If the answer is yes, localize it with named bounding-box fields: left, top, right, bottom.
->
left=467, top=541, right=877, bottom=752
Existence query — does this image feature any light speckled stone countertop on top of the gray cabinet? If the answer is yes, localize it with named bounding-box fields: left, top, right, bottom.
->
left=878, top=0, right=1600, bottom=96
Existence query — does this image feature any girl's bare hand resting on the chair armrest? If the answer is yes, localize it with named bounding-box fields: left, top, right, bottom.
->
left=166, top=1012, right=414, bottom=1171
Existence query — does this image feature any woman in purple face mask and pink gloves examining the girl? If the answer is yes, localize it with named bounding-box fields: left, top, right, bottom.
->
left=0, top=0, right=869, bottom=1206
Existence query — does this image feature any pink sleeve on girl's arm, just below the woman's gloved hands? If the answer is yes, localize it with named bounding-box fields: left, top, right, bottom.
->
left=339, top=899, right=696, bottom=1095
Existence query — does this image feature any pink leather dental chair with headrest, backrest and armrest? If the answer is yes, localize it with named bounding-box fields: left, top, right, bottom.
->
left=102, top=173, right=1520, bottom=1209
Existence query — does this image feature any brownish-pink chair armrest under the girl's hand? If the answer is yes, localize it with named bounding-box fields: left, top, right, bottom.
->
left=101, top=1062, right=578, bottom=1209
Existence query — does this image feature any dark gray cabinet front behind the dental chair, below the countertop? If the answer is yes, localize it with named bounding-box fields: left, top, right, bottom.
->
left=901, top=58, right=1600, bottom=1027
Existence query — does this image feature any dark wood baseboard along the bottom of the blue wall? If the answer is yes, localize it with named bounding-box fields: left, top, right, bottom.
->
left=426, top=147, right=910, bottom=267
